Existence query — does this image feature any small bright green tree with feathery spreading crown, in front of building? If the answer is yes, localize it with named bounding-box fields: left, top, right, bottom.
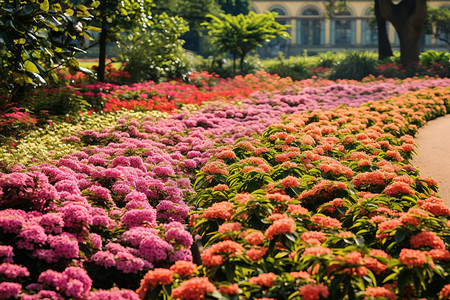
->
left=205, top=11, right=290, bottom=73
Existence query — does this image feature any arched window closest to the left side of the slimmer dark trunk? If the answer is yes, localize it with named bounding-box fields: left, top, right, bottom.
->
left=331, top=8, right=356, bottom=46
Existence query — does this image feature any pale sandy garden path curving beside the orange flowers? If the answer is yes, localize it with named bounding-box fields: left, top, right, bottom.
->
left=412, top=114, right=450, bottom=207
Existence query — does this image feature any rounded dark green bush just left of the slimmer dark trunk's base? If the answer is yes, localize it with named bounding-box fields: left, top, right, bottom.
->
left=330, top=51, right=377, bottom=80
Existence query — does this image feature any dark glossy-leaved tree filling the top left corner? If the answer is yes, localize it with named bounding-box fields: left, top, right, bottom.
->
left=0, top=0, right=93, bottom=102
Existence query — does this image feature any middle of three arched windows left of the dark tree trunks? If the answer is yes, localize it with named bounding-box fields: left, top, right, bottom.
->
left=296, top=6, right=324, bottom=46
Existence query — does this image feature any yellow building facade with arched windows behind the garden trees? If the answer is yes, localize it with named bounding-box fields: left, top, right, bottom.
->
left=252, top=0, right=450, bottom=57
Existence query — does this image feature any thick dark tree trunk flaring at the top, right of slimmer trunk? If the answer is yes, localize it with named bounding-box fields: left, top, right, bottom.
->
left=379, top=0, right=427, bottom=66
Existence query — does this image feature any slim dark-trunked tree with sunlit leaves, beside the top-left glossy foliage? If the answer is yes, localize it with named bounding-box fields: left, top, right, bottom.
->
left=87, top=0, right=153, bottom=82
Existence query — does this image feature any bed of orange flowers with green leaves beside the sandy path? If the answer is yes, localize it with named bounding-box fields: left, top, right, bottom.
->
left=139, top=88, right=450, bottom=299
